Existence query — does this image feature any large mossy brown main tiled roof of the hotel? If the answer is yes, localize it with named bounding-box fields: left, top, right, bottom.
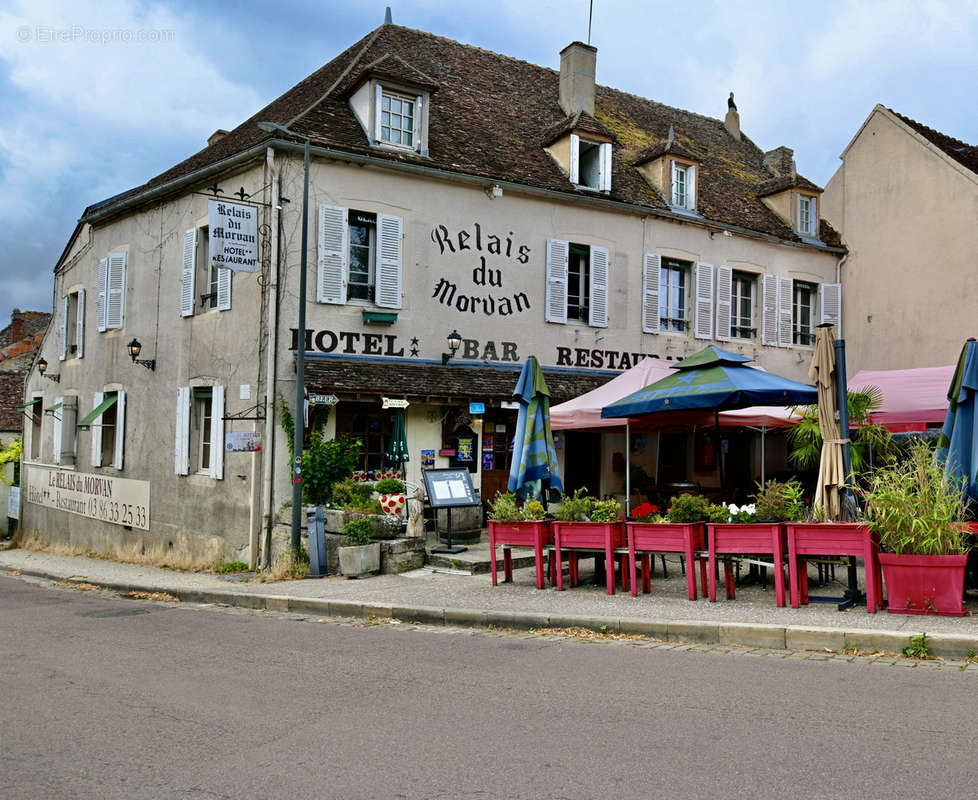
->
left=82, top=24, right=832, bottom=241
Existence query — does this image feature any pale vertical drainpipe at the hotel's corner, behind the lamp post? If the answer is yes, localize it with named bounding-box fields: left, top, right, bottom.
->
left=251, top=147, right=281, bottom=569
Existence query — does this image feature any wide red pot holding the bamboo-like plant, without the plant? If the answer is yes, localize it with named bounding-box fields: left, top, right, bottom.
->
left=880, top=553, right=968, bottom=617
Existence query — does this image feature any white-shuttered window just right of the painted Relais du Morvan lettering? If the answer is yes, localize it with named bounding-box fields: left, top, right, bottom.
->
left=546, top=239, right=608, bottom=328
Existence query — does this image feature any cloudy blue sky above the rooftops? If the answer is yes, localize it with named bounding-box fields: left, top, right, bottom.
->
left=0, top=0, right=978, bottom=327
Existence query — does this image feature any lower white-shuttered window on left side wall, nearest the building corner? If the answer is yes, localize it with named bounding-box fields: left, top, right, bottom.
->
left=175, top=386, right=224, bottom=480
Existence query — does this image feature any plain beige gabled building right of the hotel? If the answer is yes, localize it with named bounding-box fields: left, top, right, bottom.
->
left=822, top=105, right=978, bottom=375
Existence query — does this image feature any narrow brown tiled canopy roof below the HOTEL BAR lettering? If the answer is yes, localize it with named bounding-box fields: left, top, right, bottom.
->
left=305, top=360, right=613, bottom=405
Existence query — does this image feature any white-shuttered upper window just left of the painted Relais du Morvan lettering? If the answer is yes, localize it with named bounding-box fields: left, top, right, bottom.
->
left=316, top=205, right=400, bottom=308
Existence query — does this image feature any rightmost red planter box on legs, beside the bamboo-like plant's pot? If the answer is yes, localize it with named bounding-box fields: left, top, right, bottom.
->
left=784, top=522, right=883, bottom=614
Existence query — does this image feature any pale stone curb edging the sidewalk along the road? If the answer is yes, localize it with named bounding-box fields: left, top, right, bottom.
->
left=11, top=569, right=978, bottom=659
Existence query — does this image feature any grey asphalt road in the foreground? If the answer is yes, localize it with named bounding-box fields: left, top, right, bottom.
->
left=0, top=576, right=978, bottom=800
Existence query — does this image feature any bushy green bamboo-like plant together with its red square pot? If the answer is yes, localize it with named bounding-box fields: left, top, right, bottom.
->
left=865, top=442, right=969, bottom=617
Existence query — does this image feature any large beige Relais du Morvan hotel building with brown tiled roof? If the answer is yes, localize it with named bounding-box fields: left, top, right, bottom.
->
left=25, top=17, right=844, bottom=556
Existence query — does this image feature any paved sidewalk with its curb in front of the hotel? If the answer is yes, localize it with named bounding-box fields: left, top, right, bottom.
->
left=0, top=550, right=978, bottom=658
